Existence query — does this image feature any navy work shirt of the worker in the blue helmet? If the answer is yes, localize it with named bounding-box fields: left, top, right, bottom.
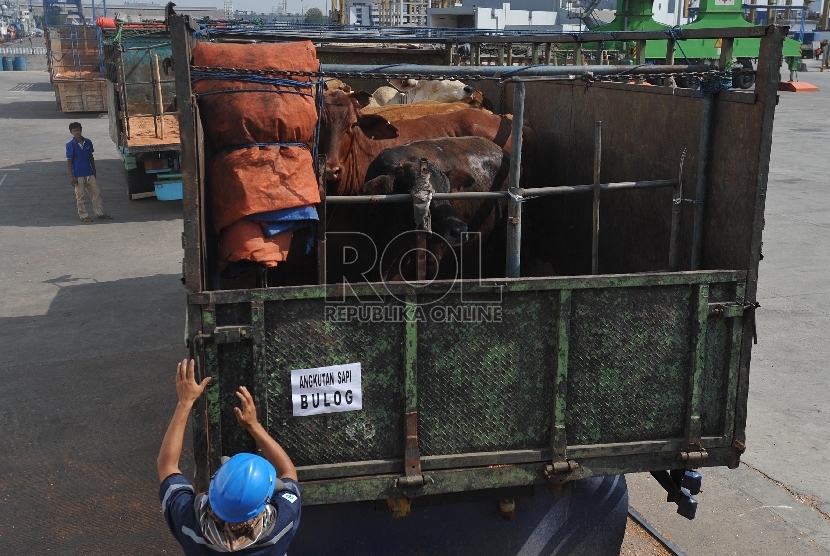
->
left=159, top=473, right=301, bottom=556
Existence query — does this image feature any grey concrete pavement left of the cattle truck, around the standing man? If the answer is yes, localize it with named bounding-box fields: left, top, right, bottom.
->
left=0, top=72, right=185, bottom=555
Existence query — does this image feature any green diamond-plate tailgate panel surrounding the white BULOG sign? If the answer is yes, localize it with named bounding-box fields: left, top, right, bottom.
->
left=264, top=299, right=404, bottom=465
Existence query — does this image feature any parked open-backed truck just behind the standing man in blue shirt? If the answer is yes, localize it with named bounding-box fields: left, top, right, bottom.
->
left=102, top=24, right=182, bottom=200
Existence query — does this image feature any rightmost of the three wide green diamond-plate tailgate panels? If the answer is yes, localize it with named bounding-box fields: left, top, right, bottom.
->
left=566, top=286, right=693, bottom=446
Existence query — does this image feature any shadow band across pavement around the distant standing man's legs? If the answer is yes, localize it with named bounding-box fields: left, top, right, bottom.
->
left=0, top=157, right=182, bottom=227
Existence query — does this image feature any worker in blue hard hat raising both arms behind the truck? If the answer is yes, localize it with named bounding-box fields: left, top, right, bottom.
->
left=156, top=359, right=301, bottom=556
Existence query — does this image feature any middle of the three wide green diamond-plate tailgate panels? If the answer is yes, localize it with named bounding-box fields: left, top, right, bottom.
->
left=418, top=292, right=558, bottom=455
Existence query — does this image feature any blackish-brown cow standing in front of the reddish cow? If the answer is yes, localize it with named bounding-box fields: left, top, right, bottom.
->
left=361, top=137, right=510, bottom=280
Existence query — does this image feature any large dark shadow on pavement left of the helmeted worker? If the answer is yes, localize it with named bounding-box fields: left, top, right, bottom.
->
left=0, top=275, right=188, bottom=555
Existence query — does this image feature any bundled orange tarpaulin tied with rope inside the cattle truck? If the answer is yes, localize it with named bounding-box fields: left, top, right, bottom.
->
left=193, top=41, right=320, bottom=266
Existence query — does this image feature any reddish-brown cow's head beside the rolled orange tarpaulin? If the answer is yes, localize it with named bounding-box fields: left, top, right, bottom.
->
left=320, top=90, right=398, bottom=181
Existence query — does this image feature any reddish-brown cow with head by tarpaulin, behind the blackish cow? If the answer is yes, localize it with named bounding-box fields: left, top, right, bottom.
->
left=320, top=91, right=536, bottom=195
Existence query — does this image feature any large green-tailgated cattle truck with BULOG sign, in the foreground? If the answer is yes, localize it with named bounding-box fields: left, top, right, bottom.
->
left=171, top=16, right=786, bottom=555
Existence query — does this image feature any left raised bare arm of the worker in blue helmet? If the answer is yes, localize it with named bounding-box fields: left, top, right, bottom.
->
left=156, top=359, right=211, bottom=481
